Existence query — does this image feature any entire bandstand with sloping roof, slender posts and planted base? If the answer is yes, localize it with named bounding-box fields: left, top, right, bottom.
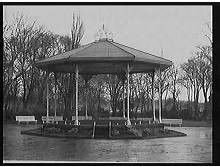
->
left=21, top=35, right=186, bottom=139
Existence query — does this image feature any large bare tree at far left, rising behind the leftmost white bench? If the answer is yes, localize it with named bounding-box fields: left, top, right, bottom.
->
left=5, top=14, right=45, bottom=108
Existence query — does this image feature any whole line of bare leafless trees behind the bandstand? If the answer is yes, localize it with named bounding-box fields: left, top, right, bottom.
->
left=3, top=14, right=212, bottom=120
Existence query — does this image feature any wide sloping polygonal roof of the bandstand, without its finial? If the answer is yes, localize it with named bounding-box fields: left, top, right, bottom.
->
left=35, top=39, right=173, bottom=74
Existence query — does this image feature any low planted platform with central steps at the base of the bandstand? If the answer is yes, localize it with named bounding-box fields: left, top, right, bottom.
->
left=21, top=123, right=186, bottom=139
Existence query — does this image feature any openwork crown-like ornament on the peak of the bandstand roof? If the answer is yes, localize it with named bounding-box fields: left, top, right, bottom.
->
left=95, top=24, right=113, bottom=41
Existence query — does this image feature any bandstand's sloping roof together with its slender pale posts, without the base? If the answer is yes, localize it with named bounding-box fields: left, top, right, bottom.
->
left=36, top=38, right=173, bottom=125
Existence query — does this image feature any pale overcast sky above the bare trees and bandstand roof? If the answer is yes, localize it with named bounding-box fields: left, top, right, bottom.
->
left=3, top=5, right=212, bottom=100
